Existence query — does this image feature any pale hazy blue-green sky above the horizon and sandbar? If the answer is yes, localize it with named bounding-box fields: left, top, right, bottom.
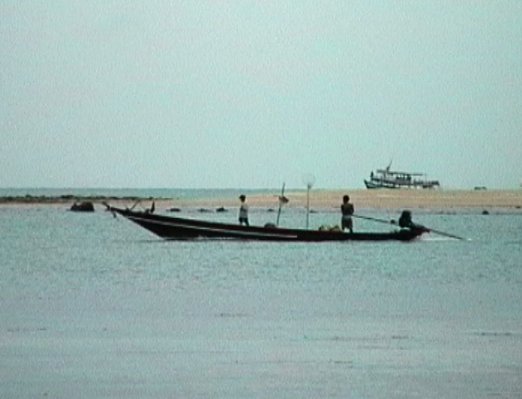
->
left=0, top=0, right=522, bottom=189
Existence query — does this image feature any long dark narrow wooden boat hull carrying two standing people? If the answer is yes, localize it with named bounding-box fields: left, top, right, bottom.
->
left=107, top=205, right=427, bottom=242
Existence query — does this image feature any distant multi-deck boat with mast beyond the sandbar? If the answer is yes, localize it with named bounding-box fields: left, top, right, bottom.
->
left=364, top=162, right=440, bottom=189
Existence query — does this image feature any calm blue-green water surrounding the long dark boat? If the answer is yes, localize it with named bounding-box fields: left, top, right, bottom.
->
left=0, top=200, right=522, bottom=398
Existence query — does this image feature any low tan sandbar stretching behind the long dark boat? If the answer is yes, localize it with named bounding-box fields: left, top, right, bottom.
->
left=0, top=189, right=522, bottom=212
